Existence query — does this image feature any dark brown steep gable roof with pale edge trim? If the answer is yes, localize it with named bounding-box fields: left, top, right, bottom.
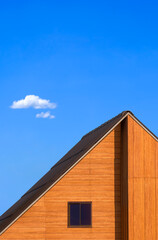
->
left=0, top=111, right=158, bottom=235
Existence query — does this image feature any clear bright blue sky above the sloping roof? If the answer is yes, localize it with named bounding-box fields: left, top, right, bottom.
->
left=0, top=0, right=158, bottom=214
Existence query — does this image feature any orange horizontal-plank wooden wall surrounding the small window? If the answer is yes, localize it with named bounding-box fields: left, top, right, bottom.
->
left=0, top=125, right=121, bottom=240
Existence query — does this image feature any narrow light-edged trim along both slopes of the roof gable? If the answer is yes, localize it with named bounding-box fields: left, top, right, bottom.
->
left=0, top=111, right=158, bottom=235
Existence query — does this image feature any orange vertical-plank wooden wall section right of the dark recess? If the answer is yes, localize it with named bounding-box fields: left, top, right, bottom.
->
left=128, top=116, right=158, bottom=240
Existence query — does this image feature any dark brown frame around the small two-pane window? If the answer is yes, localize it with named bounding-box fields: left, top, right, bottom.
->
left=67, top=201, right=92, bottom=228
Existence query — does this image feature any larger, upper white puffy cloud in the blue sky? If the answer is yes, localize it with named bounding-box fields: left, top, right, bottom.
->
left=11, top=95, right=56, bottom=109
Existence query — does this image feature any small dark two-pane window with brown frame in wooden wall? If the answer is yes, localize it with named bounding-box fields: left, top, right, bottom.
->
left=68, top=202, right=92, bottom=227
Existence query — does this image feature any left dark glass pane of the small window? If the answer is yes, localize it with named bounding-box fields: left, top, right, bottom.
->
left=70, top=203, right=80, bottom=226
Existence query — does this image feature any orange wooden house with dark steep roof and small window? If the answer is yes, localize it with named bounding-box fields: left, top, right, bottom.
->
left=0, top=111, right=158, bottom=240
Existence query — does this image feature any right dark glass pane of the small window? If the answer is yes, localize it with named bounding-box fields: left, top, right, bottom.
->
left=81, top=203, right=91, bottom=225
